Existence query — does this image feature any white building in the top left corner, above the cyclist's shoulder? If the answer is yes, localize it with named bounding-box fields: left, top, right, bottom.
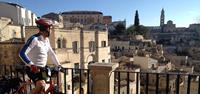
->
left=0, top=2, right=37, bottom=26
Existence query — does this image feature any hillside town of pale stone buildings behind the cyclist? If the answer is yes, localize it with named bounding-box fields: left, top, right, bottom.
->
left=0, top=2, right=200, bottom=94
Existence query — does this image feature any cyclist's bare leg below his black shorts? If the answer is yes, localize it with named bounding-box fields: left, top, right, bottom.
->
left=30, top=80, right=46, bottom=94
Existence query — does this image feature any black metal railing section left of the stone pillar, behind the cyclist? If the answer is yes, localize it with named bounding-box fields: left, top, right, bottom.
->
left=0, top=65, right=90, bottom=94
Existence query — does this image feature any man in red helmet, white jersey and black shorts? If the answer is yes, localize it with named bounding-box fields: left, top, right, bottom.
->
left=19, top=18, right=61, bottom=94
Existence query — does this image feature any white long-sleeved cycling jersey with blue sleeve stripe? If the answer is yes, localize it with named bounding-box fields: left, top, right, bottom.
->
left=19, top=34, right=60, bottom=67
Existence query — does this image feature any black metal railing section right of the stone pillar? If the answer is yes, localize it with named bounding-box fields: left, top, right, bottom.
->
left=114, top=70, right=200, bottom=94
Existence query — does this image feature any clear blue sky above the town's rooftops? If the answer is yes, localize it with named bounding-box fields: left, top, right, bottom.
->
left=0, top=0, right=200, bottom=27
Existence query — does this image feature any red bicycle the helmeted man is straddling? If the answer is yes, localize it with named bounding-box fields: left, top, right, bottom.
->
left=14, top=68, right=63, bottom=94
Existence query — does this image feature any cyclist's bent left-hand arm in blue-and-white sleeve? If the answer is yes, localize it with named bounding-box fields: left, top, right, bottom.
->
left=19, top=36, right=37, bottom=65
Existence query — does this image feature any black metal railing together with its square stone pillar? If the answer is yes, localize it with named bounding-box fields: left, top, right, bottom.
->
left=0, top=63, right=200, bottom=94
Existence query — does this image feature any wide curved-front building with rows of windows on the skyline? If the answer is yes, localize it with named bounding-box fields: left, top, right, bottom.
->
left=61, top=11, right=103, bottom=26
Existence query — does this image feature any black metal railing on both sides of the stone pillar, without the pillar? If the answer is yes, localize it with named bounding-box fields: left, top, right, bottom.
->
left=0, top=65, right=200, bottom=94
